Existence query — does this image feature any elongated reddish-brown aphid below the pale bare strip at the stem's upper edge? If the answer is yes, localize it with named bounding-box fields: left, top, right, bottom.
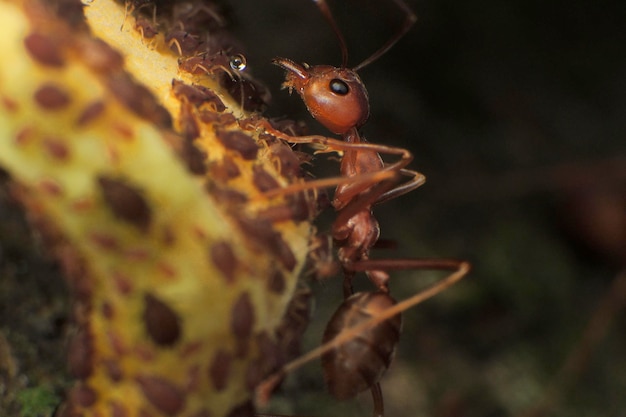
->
left=106, top=73, right=172, bottom=127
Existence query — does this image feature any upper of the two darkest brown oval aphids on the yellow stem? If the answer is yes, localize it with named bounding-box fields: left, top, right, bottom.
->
left=98, top=176, right=152, bottom=233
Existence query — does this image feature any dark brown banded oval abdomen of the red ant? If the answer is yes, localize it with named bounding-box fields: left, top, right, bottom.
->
left=322, top=291, right=402, bottom=400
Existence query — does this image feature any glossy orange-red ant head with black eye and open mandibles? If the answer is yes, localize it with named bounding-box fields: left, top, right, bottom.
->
left=272, top=58, right=370, bottom=135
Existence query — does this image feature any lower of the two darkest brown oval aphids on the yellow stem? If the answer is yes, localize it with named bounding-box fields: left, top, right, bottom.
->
left=142, top=293, right=181, bottom=346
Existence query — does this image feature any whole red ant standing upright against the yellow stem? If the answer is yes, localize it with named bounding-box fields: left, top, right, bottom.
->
left=256, top=0, right=470, bottom=417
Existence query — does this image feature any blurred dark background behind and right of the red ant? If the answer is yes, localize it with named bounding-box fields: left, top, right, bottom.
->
left=228, top=0, right=626, bottom=417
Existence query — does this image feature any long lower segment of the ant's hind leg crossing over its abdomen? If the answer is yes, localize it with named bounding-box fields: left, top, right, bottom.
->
left=255, top=262, right=470, bottom=404
